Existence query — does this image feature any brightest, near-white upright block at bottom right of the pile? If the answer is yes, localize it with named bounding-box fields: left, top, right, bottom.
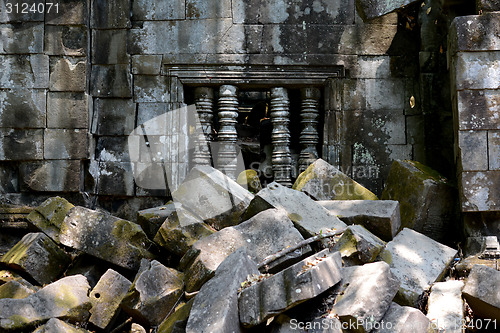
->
left=427, top=280, right=465, bottom=333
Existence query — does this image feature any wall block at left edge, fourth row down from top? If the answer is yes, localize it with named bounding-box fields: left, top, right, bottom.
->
left=0, top=87, right=47, bottom=128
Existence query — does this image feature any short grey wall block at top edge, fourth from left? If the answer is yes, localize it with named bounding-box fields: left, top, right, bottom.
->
left=132, top=0, right=186, bottom=21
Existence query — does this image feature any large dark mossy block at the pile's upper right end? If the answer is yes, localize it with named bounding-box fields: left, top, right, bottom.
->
left=382, top=160, right=456, bottom=241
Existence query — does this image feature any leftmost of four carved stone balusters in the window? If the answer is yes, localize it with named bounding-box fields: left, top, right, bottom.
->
left=193, top=87, right=214, bottom=166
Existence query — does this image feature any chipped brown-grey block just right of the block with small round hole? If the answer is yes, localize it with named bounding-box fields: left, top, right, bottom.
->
left=121, top=259, right=184, bottom=326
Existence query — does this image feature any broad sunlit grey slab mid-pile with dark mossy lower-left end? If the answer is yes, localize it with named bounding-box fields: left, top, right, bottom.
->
left=180, top=209, right=310, bottom=292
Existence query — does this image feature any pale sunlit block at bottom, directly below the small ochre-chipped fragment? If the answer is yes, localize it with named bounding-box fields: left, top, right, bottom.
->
left=331, top=261, right=399, bottom=332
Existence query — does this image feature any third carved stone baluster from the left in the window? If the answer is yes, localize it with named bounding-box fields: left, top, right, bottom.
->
left=271, top=87, right=292, bottom=187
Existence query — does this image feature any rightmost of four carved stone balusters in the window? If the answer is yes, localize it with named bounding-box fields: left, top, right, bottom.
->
left=299, top=87, right=321, bottom=172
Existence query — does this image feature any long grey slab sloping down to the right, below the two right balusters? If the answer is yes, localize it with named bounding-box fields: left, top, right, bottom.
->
left=242, top=182, right=346, bottom=237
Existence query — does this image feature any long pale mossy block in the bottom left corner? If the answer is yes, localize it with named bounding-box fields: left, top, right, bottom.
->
left=0, top=275, right=92, bottom=332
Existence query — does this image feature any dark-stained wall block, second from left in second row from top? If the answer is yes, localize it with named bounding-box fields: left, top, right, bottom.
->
left=44, top=25, right=87, bottom=56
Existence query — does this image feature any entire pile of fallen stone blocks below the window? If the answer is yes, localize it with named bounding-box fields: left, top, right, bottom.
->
left=0, top=160, right=500, bottom=333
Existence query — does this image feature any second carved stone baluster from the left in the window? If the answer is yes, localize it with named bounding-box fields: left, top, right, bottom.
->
left=217, top=85, right=238, bottom=179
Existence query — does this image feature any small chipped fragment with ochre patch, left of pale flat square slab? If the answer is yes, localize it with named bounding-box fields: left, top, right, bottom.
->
left=333, top=225, right=385, bottom=266
